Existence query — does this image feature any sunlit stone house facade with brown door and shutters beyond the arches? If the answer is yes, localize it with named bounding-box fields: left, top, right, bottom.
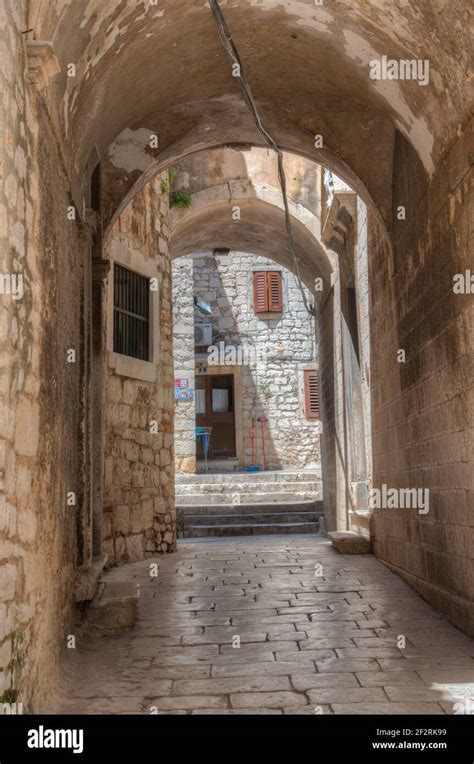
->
left=173, top=251, right=320, bottom=473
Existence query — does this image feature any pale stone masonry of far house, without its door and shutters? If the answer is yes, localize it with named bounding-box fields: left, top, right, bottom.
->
left=173, top=252, right=320, bottom=469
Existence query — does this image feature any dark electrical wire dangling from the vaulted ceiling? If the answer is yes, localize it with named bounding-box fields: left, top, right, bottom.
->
left=209, top=0, right=316, bottom=317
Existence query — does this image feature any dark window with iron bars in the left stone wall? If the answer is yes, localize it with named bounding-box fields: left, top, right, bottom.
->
left=114, top=263, right=150, bottom=361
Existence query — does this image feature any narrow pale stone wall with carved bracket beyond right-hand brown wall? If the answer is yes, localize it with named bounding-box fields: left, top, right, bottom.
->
left=318, top=184, right=372, bottom=533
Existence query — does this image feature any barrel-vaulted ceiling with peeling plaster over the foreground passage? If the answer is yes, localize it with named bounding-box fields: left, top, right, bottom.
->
left=29, top=0, right=473, bottom=230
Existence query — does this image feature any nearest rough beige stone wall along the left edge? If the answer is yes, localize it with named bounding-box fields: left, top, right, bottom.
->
left=0, top=2, right=88, bottom=711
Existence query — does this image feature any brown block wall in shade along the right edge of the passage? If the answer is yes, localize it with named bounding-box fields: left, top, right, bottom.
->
left=369, top=123, right=474, bottom=633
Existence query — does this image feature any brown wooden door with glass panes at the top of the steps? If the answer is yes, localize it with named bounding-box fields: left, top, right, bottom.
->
left=196, top=374, right=236, bottom=460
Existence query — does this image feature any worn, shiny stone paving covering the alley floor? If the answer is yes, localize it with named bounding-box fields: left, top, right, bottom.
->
left=58, top=535, right=474, bottom=714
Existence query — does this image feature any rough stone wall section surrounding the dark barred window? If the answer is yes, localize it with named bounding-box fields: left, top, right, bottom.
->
left=103, top=177, right=176, bottom=562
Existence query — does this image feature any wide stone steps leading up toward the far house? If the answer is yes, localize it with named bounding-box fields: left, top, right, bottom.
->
left=176, top=469, right=323, bottom=538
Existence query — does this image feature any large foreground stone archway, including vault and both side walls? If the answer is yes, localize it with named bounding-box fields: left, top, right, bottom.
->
left=0, top=0, right=473, bottom=708
